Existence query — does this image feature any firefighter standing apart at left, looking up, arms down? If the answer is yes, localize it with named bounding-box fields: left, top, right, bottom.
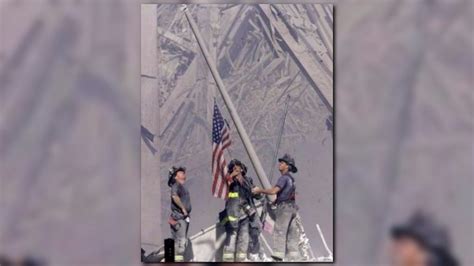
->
left=168, top=166, right=191, bottom=262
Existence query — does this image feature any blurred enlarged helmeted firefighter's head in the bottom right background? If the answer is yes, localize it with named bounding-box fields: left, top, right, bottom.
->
left=391, top=211, right=458, bottom=266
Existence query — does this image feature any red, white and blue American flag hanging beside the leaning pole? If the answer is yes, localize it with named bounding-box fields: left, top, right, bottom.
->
left=211, top=102, right=231, bottom=199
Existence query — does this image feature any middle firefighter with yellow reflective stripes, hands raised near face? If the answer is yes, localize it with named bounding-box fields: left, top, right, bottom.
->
left=221, top=159, right=256, bottom=262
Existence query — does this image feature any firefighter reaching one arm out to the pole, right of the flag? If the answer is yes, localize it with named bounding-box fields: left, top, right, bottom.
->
left=252, top=154, right=300, bottom=261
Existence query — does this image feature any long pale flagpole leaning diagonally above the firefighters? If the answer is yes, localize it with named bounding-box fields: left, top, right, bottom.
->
left=182, top=5, right=275, bottom=201
